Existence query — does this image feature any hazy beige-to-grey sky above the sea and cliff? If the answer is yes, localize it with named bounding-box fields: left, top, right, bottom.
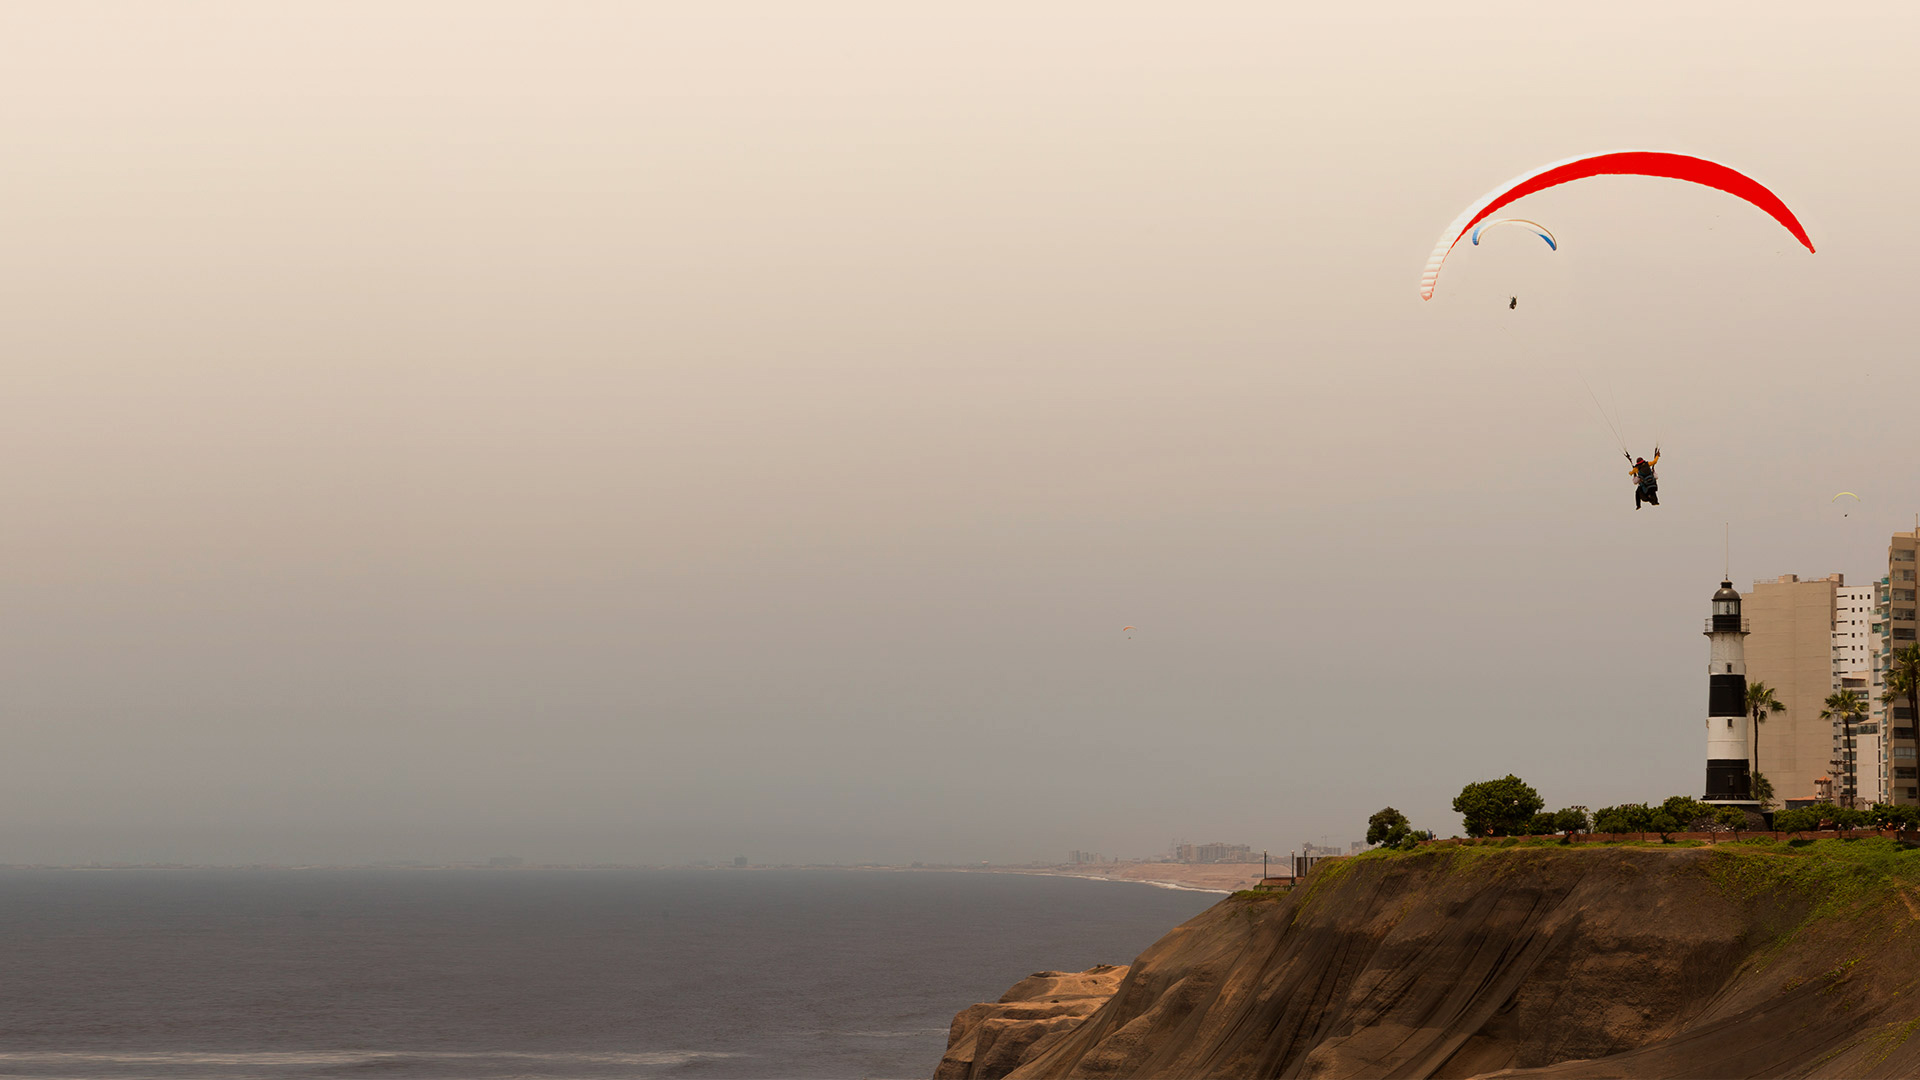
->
left=0, top=0, right=1920, bottom=861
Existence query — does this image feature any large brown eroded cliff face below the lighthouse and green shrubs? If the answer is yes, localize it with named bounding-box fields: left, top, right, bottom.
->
left=941, top=842, right=1920, bottom=1080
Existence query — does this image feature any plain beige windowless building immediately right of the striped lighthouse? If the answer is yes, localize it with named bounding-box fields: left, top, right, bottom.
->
left=1741, top=575, right=1843, bottom=805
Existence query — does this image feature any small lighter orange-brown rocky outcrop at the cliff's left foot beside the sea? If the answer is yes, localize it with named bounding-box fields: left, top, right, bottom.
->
left=933, top=965, right=1127, bottom=1080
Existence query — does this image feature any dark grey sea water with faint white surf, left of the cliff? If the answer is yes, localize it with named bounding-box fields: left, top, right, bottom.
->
left=0, top=871, right=1219, bottom=1080
